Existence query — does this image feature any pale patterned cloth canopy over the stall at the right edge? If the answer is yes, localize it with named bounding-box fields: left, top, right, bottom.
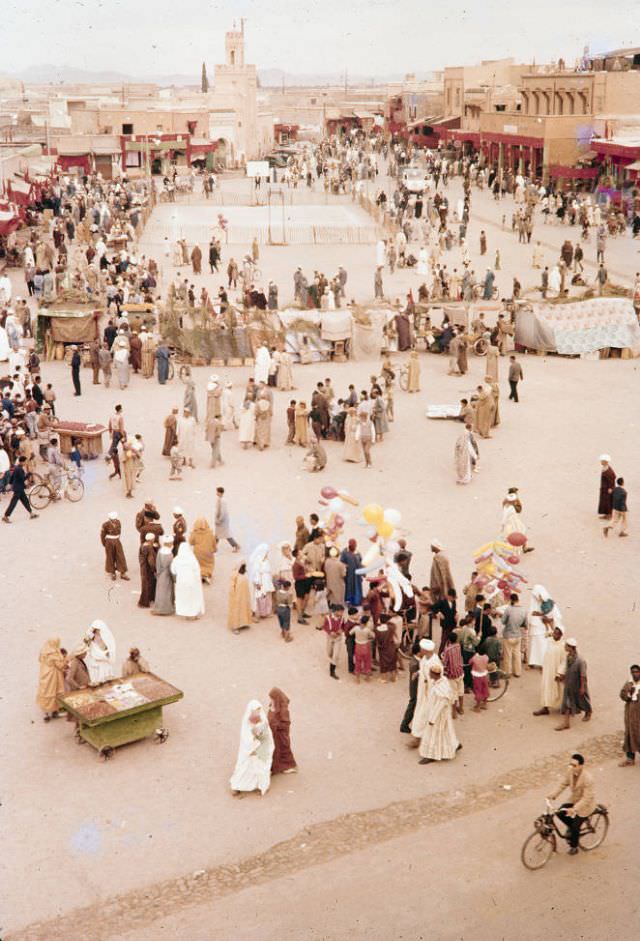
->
left=515, top=297, right=640, bottom=356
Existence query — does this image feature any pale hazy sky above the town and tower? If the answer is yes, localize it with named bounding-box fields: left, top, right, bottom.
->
left=0, top=0, right=640, bottom=77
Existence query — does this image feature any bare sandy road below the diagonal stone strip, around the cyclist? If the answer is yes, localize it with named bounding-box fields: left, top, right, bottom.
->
left=113, top=768, right=640, bottom=941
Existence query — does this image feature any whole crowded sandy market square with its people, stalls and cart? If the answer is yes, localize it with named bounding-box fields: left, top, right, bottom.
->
left=0, top=14, right=640, bottom=941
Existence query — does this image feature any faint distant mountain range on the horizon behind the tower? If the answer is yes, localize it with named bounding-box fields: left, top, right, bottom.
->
left=6, top=65, right=432, bottom=88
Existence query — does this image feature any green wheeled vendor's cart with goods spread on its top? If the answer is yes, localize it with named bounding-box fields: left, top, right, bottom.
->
left=58, top=673, right=183, bottom=761
